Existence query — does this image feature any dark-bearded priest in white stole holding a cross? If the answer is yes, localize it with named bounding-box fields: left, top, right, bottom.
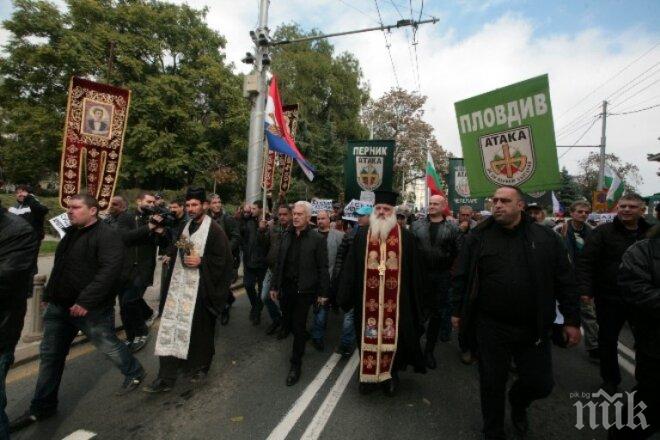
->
left=144, top=188, right=233, bottom=393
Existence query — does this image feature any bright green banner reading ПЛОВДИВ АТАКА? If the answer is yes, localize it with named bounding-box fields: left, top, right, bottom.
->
left=454, top=75, right=561, bottom=197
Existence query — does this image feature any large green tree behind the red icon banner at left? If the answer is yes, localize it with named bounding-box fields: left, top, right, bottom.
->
left=0, top=0, right=248, bottom=201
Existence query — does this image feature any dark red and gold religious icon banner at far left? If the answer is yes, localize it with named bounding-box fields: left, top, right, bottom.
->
left=60, top=77, right=131, bottom=210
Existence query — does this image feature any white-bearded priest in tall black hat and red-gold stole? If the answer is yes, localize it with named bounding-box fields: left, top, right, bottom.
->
left=337, top=191, right=426, bottom=396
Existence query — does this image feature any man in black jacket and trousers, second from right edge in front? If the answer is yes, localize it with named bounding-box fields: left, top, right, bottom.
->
left=577, top=194, right=650, bottom=395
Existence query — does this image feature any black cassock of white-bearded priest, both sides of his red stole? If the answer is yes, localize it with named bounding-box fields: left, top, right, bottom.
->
left=337, top=228, right=426, bottom=380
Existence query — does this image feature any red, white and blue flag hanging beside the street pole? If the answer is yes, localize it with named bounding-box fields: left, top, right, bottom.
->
left=264, top=76, right=315, bottom=180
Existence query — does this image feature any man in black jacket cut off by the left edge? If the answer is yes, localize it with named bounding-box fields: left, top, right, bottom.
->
left=0, top=202, right=39, bottom=438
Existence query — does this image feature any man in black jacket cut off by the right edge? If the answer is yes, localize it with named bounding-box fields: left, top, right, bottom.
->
left=611, top=225, right=660, bottom=439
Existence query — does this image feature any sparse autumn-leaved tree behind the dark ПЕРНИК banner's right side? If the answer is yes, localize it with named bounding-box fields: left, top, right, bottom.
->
left=363, top=88, right=450, bottom=196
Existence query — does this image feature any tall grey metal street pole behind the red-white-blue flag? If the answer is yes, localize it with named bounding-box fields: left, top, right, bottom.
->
left=245, top=0, right=270, bottom=208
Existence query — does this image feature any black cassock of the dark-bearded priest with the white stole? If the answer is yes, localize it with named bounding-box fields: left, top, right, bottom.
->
left=156, top=217, right=233, bottom=380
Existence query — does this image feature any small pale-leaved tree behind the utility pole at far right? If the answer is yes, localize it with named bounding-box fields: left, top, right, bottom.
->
left=576, top=152, right=644, bottom=200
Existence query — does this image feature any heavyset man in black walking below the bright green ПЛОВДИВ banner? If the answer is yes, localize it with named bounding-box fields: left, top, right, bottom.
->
left=452, top=186, right=580, bottom=439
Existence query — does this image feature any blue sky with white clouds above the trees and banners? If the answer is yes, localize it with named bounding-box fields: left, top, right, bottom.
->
left=0, top=0, right=660, bottom=195
